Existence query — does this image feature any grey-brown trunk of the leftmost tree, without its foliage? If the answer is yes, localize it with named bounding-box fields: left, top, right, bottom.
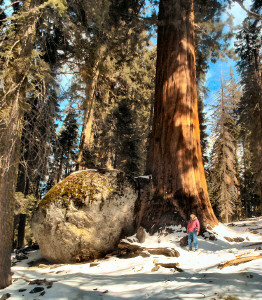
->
left=0, top=0, right=37, bottom=289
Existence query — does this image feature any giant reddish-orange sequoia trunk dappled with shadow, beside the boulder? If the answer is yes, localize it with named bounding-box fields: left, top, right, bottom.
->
left=141, top=0, right=217, bottom=228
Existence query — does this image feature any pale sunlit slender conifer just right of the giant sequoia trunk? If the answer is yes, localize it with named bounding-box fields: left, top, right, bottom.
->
left=210, top=70, right=240, bottom=223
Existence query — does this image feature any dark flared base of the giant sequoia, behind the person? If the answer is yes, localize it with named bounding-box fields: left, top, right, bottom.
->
left=136, top=177, right=218, bottom=234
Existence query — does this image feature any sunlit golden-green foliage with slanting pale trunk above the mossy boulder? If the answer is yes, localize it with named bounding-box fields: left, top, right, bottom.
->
left=64, top=0, right=154, bottom=172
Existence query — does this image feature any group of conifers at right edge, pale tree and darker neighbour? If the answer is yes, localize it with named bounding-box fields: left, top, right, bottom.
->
left=208, top=1, right=262, bottom=222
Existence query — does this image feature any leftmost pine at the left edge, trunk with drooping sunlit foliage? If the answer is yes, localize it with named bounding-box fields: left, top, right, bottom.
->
left=0, top=0, right=65, bottom=288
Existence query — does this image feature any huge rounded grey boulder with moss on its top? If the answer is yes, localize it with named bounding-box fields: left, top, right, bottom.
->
left=32, top=170, right=137, bottom=263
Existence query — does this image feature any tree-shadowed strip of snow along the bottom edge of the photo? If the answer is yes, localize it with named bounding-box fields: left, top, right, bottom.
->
left=36, top=271, right=262, bottom=300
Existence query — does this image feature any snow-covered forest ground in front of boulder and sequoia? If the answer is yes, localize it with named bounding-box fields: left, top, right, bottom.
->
left=0, top=217, right=262, bottom=300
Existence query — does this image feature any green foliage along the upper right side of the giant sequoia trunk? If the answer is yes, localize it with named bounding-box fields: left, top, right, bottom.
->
left=194, top=0, right=233, bottom=167
